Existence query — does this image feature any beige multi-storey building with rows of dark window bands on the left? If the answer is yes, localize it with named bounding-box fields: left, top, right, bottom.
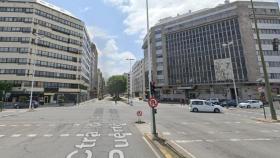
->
left=0, top=0, right=96, bottom=103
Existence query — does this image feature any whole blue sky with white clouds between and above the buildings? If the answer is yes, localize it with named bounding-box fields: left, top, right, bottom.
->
left=45, top=0, right=280, bottom=78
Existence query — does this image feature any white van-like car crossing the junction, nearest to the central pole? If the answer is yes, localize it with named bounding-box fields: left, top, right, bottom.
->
left=189, top=99, right=223, bottom=113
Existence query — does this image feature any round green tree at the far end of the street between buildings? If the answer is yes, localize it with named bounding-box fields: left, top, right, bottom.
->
left=107, top=75, right=127, bottom=98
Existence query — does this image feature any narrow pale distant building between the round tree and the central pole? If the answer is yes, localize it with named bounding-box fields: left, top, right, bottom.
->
left=131, top=59, right=145, bottom=98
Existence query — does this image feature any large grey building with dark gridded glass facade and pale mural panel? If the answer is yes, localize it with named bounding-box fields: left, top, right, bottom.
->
left=143, top=1, right=280, bottom=99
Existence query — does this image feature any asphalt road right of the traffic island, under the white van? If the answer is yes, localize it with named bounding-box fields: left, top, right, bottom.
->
left=131, top=99, right=280, bottom=158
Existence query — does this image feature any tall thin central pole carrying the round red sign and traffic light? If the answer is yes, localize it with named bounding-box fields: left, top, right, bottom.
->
left=146, top=0, right=158, bottom=138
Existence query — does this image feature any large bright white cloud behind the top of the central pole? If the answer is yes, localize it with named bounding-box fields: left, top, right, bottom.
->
left=104, top=0, right=279, bottom=39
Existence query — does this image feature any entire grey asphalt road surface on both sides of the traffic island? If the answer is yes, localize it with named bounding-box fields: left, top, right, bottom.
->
left=0, top=100, right=280, bottom=158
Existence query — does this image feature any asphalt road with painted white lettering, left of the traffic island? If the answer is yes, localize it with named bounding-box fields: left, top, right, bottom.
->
left=0, top=101, right=157, bottom=158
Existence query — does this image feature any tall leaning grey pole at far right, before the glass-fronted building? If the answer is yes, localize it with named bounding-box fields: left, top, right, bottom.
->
left=251, top=0, right=277, bottom=120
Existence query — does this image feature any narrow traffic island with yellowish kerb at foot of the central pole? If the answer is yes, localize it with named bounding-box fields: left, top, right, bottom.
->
left=144, top=133, right=191, bottom=158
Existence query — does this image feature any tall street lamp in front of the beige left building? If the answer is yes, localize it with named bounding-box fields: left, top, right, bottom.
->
left=29, top=33, right=44, bottom=111
